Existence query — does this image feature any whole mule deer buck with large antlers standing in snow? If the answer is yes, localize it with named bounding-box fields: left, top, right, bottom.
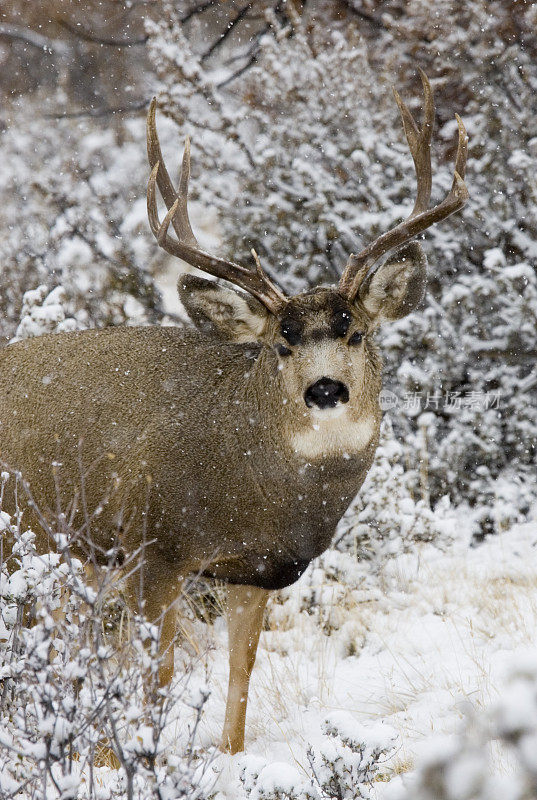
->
left=0, top=72, right=468, bottom=753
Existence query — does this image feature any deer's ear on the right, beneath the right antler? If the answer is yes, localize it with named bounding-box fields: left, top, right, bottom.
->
left=357, top=242, right=427, bottom=325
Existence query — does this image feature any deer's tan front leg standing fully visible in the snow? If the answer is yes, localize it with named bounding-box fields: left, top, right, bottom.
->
left=221, top=585, right=269, bottom=754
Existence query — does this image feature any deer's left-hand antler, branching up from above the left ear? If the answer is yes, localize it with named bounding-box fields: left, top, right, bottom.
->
left=147, top=98, right=287, bottom=314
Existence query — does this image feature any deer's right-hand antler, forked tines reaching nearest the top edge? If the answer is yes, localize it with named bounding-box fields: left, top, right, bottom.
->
left=339, top=69, right=468, bottom=300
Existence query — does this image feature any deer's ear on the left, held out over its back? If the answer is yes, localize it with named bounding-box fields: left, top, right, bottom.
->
left=177, top=275, right=270, bottom=344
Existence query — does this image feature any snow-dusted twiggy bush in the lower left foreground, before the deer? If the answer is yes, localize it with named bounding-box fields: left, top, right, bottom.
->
left=0, top=472, right=211, bottom=800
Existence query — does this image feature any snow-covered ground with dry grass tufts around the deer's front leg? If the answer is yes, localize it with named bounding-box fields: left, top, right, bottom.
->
left=168, top=520, right=537, bottom=800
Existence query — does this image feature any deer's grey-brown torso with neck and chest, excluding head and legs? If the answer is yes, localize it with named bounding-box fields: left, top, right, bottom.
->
left=0, top=318, right=378, bottom=589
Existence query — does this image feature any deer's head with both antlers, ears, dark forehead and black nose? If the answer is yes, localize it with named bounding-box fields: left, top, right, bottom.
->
left=147, top=70, right=468, bottom=432
